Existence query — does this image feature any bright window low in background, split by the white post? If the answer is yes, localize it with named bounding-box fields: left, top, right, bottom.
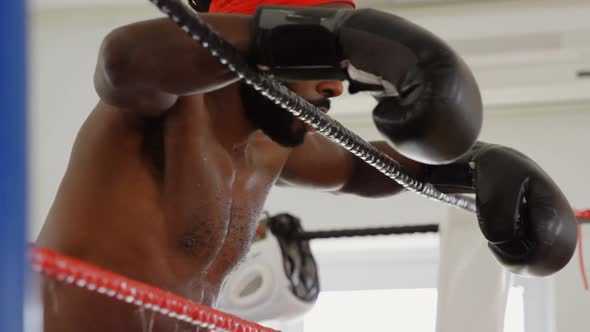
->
left=260, top=235, right=555, bottom=332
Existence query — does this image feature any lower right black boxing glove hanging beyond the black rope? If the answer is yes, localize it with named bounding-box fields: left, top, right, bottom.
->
left=424, top=142, right=577, bottom=276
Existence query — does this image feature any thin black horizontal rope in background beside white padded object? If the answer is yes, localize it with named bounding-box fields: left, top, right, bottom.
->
left=293, top=224, right=438, bottom=240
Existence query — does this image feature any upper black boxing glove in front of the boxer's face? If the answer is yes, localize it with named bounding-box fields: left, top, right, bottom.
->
left=252, top=6, right=482, bottom=164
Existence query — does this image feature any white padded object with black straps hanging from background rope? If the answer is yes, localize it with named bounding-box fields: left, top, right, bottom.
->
left=218, top=214, right=320, bottom=322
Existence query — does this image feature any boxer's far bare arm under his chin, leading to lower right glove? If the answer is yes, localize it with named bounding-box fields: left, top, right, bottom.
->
left=278, top=134, right=420, bottom=197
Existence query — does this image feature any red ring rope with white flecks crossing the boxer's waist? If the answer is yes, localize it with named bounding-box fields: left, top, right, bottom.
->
left=29, top=246, right=279, bottom=332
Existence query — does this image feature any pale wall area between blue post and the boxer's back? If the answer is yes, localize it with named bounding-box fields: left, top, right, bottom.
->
left=29, top=6, right=158, bottom=233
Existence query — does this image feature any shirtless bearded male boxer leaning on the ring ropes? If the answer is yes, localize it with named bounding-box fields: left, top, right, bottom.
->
left=38, top=0, right=575, bottom=332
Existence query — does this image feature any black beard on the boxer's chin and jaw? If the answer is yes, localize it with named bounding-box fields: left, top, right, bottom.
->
left=240, top=83, right=330, bottom=148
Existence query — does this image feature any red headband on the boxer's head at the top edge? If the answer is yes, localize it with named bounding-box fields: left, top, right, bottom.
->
left=209, top=0, right=355, bottom=15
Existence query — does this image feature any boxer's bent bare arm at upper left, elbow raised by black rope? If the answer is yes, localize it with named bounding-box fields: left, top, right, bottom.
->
left=94, top=14, right=252, bottom=115
